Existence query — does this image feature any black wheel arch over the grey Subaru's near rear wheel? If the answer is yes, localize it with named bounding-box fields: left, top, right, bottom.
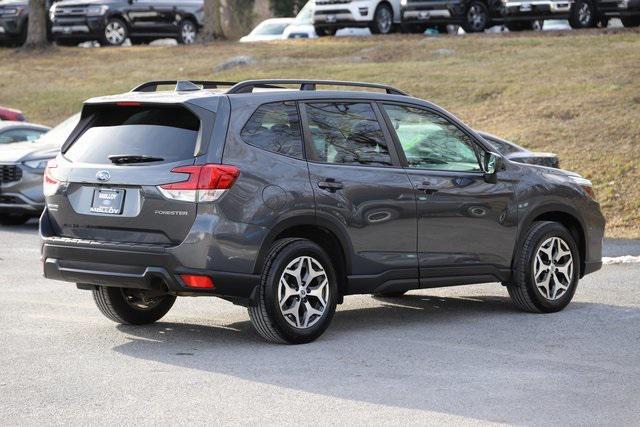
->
left=254, top=215, right=352, bottom=295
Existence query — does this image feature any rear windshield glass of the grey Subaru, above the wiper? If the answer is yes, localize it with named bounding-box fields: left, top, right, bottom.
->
left=65, top=106, right=200, bottom=163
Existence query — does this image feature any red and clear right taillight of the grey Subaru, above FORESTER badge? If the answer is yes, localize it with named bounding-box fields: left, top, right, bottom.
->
left=158, top=164, right=240, bottom=202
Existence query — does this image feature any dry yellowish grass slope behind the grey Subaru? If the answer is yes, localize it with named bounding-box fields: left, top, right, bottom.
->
left=0, top=30, right=640, bottom=238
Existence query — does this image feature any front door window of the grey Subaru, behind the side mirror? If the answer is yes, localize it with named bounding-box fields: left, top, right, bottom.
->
left=384, top=105, right=480, bottom=172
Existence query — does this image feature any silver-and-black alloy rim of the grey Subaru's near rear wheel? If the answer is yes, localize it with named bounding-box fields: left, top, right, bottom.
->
left=278, top=256, right=329, bottom=329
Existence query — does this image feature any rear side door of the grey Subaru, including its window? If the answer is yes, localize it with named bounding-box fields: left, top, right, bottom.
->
left=301, top=100, right=418, bottom=293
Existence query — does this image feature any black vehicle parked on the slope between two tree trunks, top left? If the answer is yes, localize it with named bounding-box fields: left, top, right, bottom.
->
left=49, top=0, right=204, bottom=46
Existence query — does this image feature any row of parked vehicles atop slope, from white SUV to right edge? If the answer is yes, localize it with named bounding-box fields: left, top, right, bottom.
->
left=313, top=0, right=640, bottom=36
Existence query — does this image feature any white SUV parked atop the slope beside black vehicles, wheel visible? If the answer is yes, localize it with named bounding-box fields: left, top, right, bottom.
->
left=313, top=0, right=400, bottom=36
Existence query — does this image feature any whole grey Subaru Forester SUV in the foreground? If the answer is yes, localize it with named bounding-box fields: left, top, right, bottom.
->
left=40, top=80, right=605, bottom=343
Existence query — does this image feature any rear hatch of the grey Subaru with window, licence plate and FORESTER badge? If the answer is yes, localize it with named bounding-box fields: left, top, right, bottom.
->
left=45, top=102, right=216, bottom=246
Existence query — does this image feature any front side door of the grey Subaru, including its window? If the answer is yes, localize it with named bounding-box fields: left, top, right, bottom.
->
left=382, top=104, right=517, bottom=287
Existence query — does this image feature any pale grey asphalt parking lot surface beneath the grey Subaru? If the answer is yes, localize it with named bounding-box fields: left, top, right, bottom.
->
left=0, top=224, right=640, bottom=425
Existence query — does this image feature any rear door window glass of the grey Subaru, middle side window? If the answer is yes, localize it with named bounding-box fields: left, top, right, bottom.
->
left=306, top=102, right=391, bottom=166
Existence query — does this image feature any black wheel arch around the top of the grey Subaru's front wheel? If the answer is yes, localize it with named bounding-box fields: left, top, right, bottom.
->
left=514, top=204, right=587, bottom=278
